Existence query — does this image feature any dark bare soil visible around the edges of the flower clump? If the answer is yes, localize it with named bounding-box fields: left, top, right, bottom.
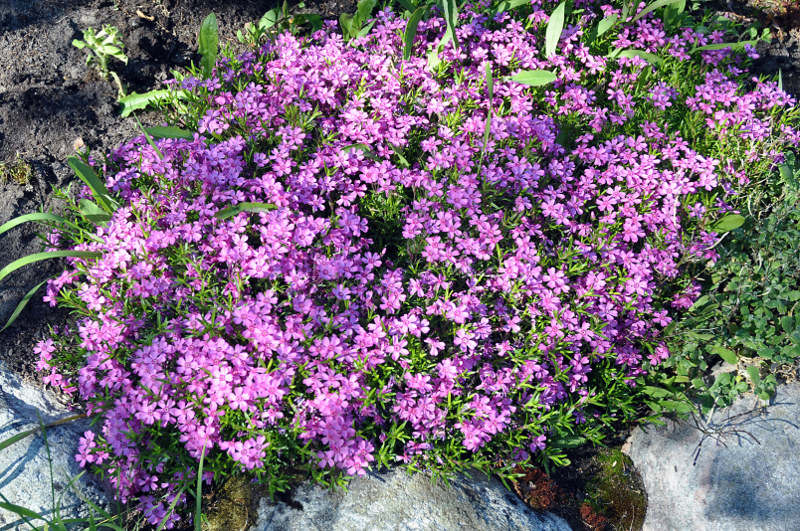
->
left=0, top=0, right=800, bottom=529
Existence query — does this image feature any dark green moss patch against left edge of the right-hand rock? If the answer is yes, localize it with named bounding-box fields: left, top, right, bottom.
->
left=587, top=448, right=647, bottom=529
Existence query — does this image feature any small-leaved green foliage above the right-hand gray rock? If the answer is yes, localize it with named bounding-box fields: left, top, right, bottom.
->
left=670, top=154, right=800, bottom=412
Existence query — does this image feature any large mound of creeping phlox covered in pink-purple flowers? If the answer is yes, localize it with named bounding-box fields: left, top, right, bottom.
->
left=26, top=1, right=800, bottom=525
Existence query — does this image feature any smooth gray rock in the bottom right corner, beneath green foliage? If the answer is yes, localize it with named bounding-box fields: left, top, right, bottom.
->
left=628, top=384, right=800, bottom=531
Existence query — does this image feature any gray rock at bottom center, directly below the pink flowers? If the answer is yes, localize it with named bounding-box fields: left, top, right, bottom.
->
left=251, top=470, right=571, bottom=531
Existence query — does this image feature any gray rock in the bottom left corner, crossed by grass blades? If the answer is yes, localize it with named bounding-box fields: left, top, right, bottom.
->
left=0, top=362, right=109, bottom=531
